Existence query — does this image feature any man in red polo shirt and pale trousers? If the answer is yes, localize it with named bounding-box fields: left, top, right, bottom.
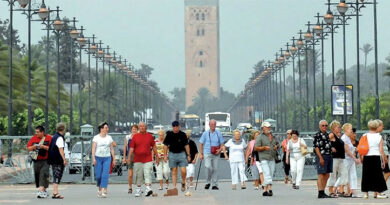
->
left=127, top=122, right=159, bottom=197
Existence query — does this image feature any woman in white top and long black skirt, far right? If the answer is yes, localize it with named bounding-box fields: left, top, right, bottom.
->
left=360, top=120, right=387, bottom=199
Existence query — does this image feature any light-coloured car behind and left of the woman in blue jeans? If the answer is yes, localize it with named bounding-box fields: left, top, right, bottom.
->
left=69, top=141, right=91, bottom=176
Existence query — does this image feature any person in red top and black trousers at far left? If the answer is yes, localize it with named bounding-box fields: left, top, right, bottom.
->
left=27, top=126, right=52, bottom=198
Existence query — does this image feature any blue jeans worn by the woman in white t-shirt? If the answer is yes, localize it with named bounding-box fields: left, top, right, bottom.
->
left=95, top=157, right=111, bottom=188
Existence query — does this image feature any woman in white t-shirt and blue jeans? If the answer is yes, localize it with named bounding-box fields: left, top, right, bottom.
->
left=92, top=122, right=115, bottom=198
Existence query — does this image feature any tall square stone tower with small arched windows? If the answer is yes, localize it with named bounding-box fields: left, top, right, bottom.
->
left=185, top=0, right=219, bottom=108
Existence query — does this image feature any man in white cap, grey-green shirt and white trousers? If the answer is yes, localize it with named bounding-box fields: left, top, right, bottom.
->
left=254, top=122, right=279, bottom=196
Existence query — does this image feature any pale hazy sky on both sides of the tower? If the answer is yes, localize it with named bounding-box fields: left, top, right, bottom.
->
left=0, top=0, right=390, bottom=97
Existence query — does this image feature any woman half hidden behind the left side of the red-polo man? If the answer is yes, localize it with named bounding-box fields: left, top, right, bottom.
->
left=122, top=124, right=138, bottom=194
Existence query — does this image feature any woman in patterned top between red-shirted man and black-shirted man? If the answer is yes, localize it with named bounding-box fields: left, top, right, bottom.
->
left=155, top=130, right=169, bottom=190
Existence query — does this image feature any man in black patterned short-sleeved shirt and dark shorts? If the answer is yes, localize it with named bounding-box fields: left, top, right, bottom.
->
left=313, top=120, right=333, bottom=198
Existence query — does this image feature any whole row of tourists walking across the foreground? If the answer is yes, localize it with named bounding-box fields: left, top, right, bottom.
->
left=27, top=117, right=390, bottom=199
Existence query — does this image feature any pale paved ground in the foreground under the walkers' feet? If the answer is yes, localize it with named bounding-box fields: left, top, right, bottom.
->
left=0, top=180, right=390, bottom=205
